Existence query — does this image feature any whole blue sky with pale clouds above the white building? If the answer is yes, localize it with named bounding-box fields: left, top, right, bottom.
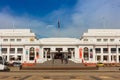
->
left=0, top=0, right=120, bottom=38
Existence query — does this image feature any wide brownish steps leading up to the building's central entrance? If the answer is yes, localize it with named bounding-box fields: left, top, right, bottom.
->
left=22, top=59, right=98, bottom=70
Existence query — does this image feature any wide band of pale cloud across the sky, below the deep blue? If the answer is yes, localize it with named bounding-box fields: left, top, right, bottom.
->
left=0, top=0, right=120, bottom=38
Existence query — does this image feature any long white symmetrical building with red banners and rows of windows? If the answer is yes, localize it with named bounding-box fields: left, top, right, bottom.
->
left=0, top=29, right=120, bottom=63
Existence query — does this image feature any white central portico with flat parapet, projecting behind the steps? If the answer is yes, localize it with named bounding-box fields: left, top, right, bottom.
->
left=40, top=38, right=81, bottom=62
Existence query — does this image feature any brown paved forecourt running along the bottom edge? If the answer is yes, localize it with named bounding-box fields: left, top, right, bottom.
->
left=0, top=71, right=120, bottom=80
